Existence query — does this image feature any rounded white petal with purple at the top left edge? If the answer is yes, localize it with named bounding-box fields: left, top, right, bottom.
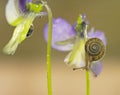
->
left=5, top=0, right=32, bottom=26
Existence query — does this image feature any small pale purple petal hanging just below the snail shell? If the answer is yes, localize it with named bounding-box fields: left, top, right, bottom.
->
left=90, top=61, right=103, bottom=77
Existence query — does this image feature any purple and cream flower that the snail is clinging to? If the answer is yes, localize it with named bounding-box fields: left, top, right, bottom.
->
left=44, top=15, right=106, bottom=76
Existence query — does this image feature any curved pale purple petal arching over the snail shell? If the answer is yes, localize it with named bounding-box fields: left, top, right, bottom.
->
left=88, top=28, right=107, bottom=45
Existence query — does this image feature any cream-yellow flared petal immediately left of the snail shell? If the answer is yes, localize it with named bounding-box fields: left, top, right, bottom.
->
left=64, top=39, right=85, bottom=68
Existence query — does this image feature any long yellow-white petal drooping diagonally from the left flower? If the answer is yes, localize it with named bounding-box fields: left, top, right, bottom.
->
left=3, top=13, right=36, bottom=55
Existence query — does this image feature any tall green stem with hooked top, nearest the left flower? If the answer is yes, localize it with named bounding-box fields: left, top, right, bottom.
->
left=44, top=1, right=52, bottom=95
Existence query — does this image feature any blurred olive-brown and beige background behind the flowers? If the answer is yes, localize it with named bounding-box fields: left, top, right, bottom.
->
left=0, top=0, right=120, bottom=95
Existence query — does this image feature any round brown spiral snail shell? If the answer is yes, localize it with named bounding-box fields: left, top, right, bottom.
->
left=85, top=38, right=105, bottom=61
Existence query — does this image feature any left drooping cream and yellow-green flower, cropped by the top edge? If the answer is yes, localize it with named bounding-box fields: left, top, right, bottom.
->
left=3, top=0, right=45, bottom=55
